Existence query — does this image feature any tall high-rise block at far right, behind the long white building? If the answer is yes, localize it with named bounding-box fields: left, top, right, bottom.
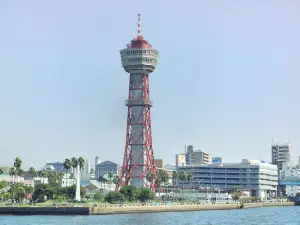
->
left=271, top=143, right=291, bottom=170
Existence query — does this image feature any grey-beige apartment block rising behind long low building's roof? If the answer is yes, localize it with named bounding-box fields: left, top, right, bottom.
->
left=185, top=145, right=210, bottom=165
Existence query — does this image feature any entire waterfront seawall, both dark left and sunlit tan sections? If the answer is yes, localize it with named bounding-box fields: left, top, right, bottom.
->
left=0, top=202, right=295, bottom=216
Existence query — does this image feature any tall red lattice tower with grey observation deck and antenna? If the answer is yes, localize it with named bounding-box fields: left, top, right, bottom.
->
left=116, top=14, right=158, bottom=191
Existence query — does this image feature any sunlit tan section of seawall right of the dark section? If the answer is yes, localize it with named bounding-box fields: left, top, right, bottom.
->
left=90, top=202, right=294, bottom=215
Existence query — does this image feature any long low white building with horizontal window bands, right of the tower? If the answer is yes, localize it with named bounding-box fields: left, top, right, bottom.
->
left=178, top=159, right=278, bottom=198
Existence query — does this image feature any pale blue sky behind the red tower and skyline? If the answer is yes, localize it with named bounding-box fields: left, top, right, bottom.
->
left=0, top=0, right=300, bottom=169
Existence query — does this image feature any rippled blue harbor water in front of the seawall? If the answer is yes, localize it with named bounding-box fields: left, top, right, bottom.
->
left=0, top=206, right=300, bottom=225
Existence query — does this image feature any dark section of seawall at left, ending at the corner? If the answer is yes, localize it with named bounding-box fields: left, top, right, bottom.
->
left=0, top=207, right=90, bottom=215
